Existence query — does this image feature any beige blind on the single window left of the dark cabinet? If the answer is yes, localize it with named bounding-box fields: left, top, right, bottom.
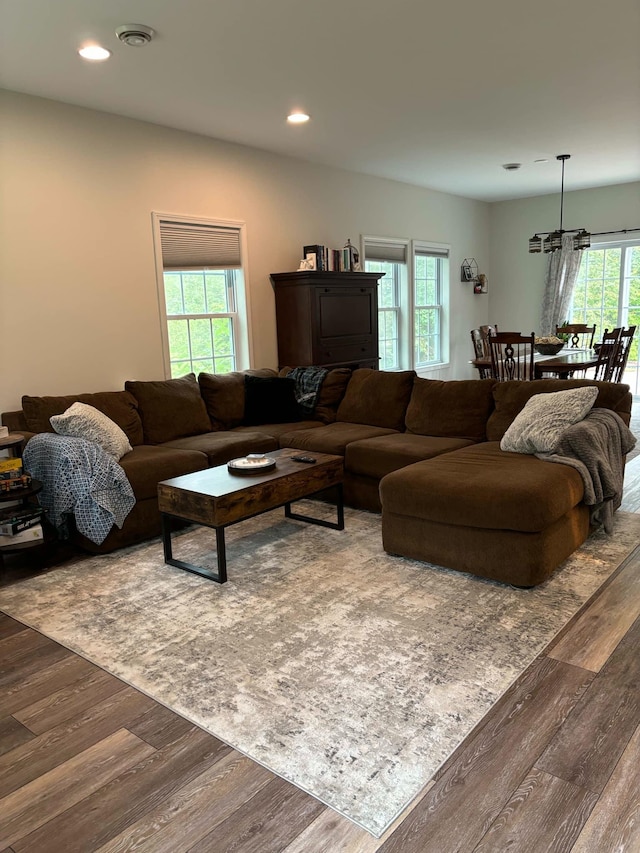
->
left=160, top=219, right=241, bottom=270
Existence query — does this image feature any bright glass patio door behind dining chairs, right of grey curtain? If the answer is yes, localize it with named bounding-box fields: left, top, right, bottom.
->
left=568, top=242, right=640, bottom=394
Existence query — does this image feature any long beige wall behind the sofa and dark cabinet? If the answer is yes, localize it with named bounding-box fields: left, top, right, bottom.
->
left=0, top=92, right=490, bottom=411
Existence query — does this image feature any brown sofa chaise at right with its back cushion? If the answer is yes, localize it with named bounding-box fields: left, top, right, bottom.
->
left=380, top=379, right=631, bottom=587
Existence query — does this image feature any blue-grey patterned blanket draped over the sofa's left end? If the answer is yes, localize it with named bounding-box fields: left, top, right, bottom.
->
left=22, top=433, right=136, bottom=545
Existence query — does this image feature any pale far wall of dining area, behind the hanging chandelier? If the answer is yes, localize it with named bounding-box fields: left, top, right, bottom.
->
left=489, top=182, right=640, bottom=332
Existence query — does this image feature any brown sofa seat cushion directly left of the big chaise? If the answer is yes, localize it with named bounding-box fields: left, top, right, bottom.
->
left=344, top=433, right=473, bottom=480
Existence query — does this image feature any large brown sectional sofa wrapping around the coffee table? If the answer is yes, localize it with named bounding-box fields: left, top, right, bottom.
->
left=2, top=368, right=632, bottom=586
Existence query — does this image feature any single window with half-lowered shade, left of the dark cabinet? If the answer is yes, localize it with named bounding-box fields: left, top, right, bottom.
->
left=154, top=214, right=248, bottom=377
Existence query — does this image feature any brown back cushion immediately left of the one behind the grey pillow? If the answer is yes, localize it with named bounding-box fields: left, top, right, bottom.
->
left=405, top=378, right=495, bottom=441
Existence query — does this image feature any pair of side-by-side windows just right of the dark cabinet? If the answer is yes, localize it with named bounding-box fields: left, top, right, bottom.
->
left=364, top=237, right=449, bottom=370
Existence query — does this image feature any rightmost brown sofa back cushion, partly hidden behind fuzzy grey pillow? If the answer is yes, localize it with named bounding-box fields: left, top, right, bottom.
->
left=487, top=379, right=633, bottom=441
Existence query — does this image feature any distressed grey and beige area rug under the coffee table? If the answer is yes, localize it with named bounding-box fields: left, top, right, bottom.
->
left=0, top=505, right=640, bottom=836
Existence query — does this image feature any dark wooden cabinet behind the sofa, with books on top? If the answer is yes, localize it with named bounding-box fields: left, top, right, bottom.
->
left=271, top=270, right=384, bottom=369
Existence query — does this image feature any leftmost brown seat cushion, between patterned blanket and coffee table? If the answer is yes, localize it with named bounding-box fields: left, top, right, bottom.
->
left=118, top=444, right=207, bottom=501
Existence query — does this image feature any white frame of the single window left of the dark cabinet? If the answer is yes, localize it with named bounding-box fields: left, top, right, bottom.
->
left=151, top=211, right=253, bottom=379
